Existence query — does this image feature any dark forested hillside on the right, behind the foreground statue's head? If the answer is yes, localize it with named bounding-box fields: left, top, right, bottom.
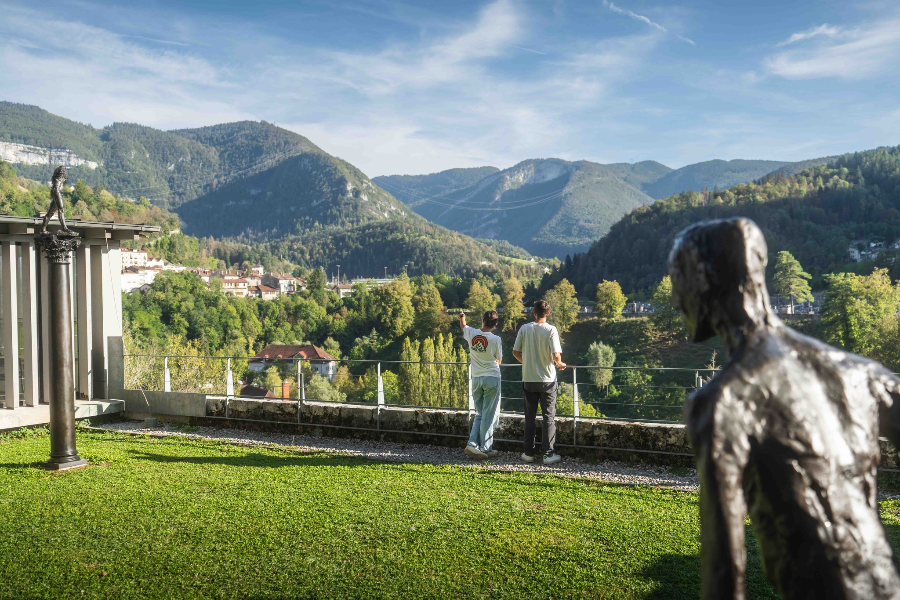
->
left=542, top=146, right=900, bottom=293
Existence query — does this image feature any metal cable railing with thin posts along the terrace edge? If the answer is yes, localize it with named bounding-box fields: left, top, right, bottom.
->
left=124, top=354, right=715, bottom=423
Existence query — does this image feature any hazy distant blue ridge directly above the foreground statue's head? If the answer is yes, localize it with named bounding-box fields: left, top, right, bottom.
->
left=641, top=160, right=790, bottom=198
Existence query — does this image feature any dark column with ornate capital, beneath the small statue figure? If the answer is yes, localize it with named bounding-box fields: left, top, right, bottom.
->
left=35, top=231, right=87, bottom=471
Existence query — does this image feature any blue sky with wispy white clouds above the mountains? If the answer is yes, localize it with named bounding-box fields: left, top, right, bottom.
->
left=0, top=0, right=900, bottom=176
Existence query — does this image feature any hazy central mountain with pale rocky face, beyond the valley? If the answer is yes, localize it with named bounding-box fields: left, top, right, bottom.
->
left=386, top=158, right=652, bottom=256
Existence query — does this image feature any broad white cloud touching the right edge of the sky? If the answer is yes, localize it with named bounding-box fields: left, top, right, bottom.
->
left=763, top=17, right=900, bottom=79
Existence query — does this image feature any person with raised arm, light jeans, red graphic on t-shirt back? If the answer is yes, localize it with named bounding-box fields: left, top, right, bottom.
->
left=459, top=310, right=503, bottom=459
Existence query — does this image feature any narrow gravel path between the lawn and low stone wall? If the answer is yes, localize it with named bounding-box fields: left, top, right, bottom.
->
left=98, top=421, right=698, bottom=491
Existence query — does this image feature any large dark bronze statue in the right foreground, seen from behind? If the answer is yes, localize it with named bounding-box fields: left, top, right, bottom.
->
left=669, top=218, right=900, bottom=600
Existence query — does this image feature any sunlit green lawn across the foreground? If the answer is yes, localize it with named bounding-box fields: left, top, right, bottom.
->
left=0, top=430, right=900, bottom=600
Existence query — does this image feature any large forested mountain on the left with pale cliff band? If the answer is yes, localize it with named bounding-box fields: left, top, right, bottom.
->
left=0, top=102, right=540, bottom=276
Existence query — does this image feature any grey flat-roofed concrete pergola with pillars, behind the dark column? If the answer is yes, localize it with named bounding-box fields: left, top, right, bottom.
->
left=0, top=215, right=159, bottom=430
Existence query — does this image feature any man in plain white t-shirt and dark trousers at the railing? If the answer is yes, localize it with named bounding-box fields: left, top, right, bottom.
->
left=513, top=300, right=566, bottom=465
